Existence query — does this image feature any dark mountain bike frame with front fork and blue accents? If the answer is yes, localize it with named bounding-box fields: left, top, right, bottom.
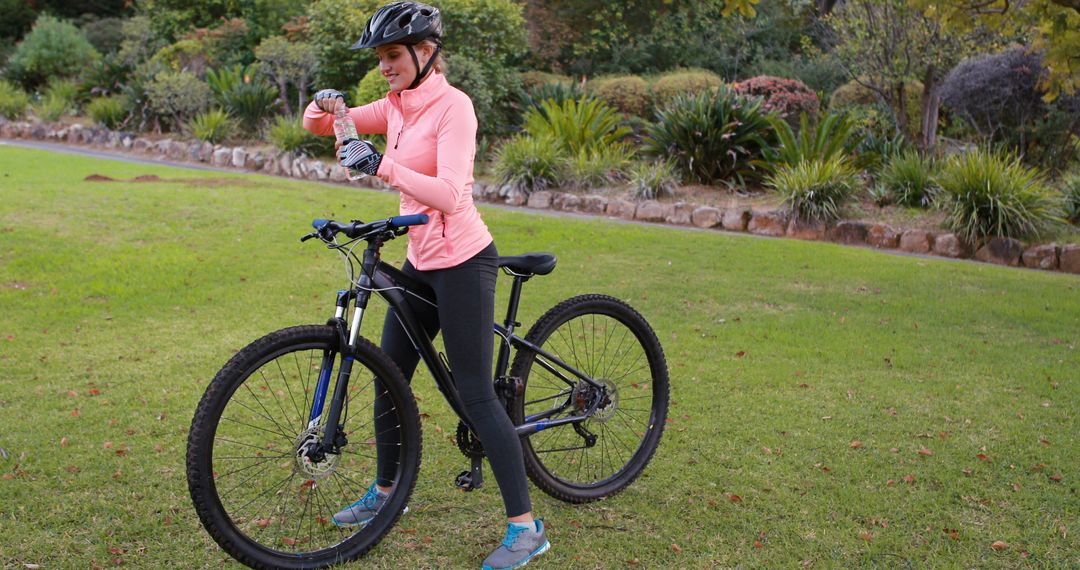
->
left=309, top=240, right=606, bottom=453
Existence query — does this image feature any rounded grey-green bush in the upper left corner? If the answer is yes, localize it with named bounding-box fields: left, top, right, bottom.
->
left=6, top=15, right=102, bottom=89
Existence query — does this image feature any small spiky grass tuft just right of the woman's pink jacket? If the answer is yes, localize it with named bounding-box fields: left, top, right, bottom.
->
left=494, top=135, right=569, bottom=193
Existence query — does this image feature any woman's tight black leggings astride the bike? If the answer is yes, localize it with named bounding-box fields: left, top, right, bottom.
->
left=375, top=243, right=532, bottom=517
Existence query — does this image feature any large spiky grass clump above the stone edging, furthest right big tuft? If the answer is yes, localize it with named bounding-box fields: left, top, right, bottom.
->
left=936, top=149, right=1059, bottom=244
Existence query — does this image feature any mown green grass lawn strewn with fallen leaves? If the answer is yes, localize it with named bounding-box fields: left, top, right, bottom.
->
left=0, top=146, right=1080, bottom=568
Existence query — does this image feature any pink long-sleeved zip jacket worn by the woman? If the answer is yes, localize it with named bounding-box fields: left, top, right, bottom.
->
left=303, top=73, right=491, bottom=271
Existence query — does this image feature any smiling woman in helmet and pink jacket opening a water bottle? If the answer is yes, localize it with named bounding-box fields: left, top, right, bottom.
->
left=303, top=2, right=550, bottom=569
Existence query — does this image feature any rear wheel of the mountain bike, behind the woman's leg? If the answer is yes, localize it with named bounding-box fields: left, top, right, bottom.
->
left=511, top=295, right=667, bottom=503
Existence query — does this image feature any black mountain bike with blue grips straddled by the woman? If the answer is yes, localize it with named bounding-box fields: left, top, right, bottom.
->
left=187, top=215, right=669, bottom=568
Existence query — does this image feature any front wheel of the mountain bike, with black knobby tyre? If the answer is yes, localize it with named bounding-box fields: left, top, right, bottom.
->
left=187, top=326, right=420, bottom=568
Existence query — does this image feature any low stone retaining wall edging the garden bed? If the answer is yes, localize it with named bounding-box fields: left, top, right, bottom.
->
left=0, top=118, right=1080, bottom=274
